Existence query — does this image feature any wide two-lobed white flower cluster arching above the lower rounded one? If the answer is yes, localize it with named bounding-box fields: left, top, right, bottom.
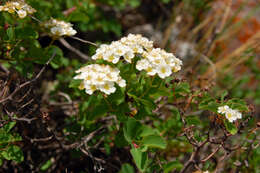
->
left=92, top=34, right=182, bottom=78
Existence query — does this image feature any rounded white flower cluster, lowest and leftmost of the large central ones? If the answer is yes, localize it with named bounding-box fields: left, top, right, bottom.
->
left=74, top=64, right=126, bottom=95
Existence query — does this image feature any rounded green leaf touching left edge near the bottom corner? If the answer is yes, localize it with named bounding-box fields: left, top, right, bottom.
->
left=1, top=145, right=24, bottom=163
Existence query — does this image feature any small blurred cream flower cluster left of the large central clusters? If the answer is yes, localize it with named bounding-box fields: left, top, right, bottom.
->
left=44, top=19, right=77, bottom=37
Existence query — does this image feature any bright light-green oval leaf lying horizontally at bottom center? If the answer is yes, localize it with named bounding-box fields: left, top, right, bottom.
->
left=142, top=135, right=167, bottom=149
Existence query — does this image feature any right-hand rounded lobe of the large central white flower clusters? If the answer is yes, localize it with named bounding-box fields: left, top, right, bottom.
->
left=136, top=48, right=182, bottom=79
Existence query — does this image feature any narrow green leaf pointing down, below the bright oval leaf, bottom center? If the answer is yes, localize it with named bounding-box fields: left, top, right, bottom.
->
left=130, top=148, right=148, bottom=172
